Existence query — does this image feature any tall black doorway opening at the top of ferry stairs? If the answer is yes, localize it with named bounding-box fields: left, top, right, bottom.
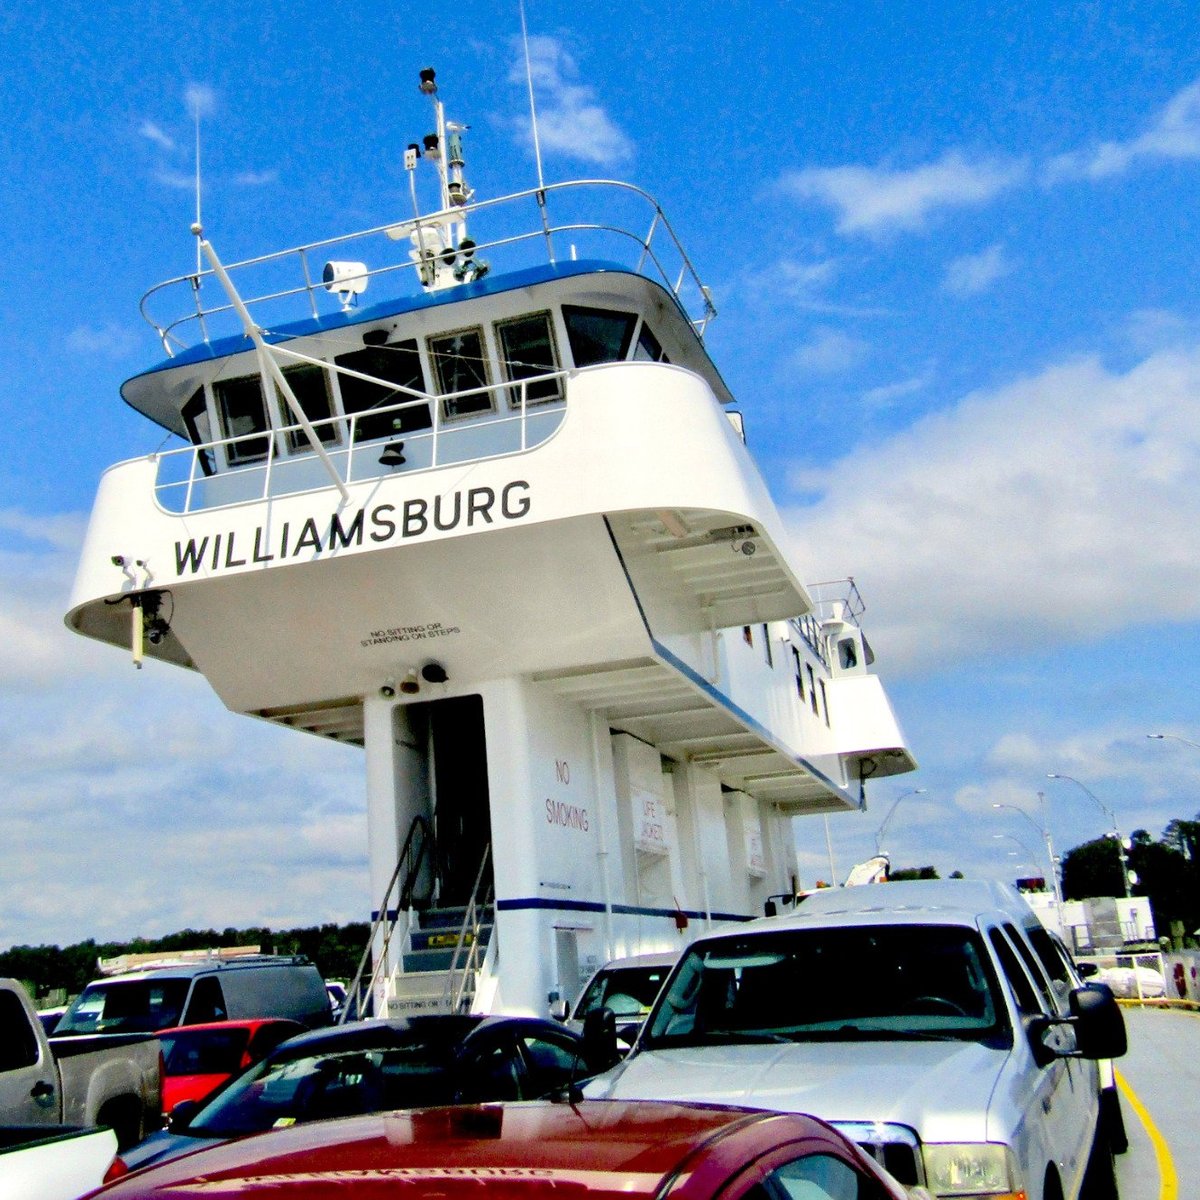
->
left=428, top=696, right=492, bottom=906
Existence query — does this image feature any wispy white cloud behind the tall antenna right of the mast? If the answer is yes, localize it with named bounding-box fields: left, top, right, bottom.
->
left=509, top=37, right=634, bottom=166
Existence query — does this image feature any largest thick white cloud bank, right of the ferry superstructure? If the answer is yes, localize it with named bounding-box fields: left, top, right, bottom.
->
left=788, top=348, right=1200, bottom=668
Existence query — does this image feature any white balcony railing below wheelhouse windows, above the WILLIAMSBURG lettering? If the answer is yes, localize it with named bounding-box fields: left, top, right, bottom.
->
left=154, top=362, right=570, bottom=514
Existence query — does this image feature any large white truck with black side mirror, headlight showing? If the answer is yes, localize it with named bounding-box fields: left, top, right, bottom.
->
left=584, top=880, right=1126, bottom=1200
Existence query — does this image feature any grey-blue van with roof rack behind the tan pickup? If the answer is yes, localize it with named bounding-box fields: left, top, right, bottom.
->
left=54, top=954, right=332, bottom=1037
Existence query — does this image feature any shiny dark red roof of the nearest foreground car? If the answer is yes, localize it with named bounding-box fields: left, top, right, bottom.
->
left=96, top=1100, right=858, bottom=1200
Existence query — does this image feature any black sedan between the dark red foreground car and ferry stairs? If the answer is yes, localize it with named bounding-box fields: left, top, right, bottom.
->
left=112, top=1014, right=611, bottom=1170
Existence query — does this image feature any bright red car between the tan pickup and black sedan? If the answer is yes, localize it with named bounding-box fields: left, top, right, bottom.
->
left=158, top=1018, right=306, bottom=1117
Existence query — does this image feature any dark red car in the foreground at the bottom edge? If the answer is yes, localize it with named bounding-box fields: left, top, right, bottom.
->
left=96, top=1100, right=907, bottom=1200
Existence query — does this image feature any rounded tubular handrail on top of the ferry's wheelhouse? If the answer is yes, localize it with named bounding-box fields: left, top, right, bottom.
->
left=139, top=179, right=716, bottom=356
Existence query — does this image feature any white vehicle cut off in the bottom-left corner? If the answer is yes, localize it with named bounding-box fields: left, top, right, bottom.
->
left=0, top=1126, right=116, bottom=1200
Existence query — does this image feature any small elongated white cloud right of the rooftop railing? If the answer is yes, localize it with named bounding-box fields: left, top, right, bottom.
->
left=780, top=150, right=1026, bottom=234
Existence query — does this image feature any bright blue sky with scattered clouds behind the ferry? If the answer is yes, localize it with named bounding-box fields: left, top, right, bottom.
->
left=0, top=0, right=1200, bottom=947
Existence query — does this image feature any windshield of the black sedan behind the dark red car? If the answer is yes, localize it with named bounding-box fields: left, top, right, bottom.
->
left=187, top=1043, right=455, bottom=1138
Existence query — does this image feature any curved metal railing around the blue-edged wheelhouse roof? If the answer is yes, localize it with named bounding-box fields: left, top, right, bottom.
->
left=139, top=179, right=716, bottom=355
